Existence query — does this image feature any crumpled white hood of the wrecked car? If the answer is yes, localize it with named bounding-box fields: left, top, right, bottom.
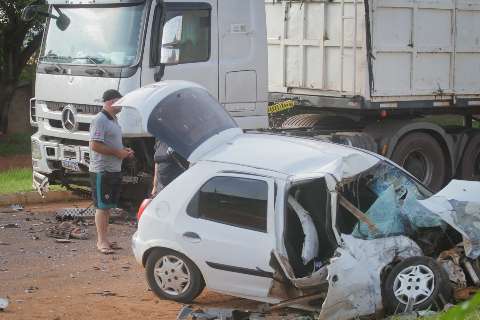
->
left=419, top=180, right=480, bottom=259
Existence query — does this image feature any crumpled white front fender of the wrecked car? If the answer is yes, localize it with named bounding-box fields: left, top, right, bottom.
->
left=320, top=234, right=423, bottom=320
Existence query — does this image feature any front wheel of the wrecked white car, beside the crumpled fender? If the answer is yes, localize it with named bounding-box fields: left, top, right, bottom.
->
left=383, top=257, right=452, bottom=314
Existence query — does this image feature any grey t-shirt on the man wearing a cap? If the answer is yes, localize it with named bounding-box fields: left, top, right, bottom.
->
left=89, top=110, right=123, bottom=172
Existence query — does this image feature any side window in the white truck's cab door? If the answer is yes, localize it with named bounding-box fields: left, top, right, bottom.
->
left=151, top=3, right=211, bottom=66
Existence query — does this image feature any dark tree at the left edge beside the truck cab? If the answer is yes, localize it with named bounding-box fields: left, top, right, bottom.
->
left=0, top=0, right=44, bottom=133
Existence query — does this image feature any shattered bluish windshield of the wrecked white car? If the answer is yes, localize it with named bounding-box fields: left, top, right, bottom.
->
left=341, top=161, right=443, bottom=239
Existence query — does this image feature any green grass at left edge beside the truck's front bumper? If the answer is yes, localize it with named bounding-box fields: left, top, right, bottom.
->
left=0, top=168, right=65, bottom=194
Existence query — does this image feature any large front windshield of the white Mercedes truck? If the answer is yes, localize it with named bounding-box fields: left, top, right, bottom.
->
left=40, top=3, right=145, bottom=66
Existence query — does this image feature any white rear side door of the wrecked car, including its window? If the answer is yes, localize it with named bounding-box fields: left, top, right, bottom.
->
left=175, top=173, right=276, bottom=298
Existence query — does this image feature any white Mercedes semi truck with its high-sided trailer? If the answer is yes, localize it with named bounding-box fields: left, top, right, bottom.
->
left=31, top=0, right=480, bottom=208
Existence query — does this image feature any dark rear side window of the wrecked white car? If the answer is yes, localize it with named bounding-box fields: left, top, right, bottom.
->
left=187, top=176, right=268, bottom=232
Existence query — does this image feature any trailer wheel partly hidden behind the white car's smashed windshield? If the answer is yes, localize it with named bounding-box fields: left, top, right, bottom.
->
left=391, top=132, right=447, bottom=191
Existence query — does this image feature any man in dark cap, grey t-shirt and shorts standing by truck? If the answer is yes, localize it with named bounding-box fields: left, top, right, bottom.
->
left=89, top=89, right=133, bottom=254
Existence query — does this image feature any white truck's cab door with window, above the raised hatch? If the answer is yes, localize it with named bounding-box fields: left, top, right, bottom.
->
left=142, top=0, right=218, bottom=98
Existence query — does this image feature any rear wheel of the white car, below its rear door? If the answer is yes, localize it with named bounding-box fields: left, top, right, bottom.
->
left=145, top=249, right=205, bottom=303
